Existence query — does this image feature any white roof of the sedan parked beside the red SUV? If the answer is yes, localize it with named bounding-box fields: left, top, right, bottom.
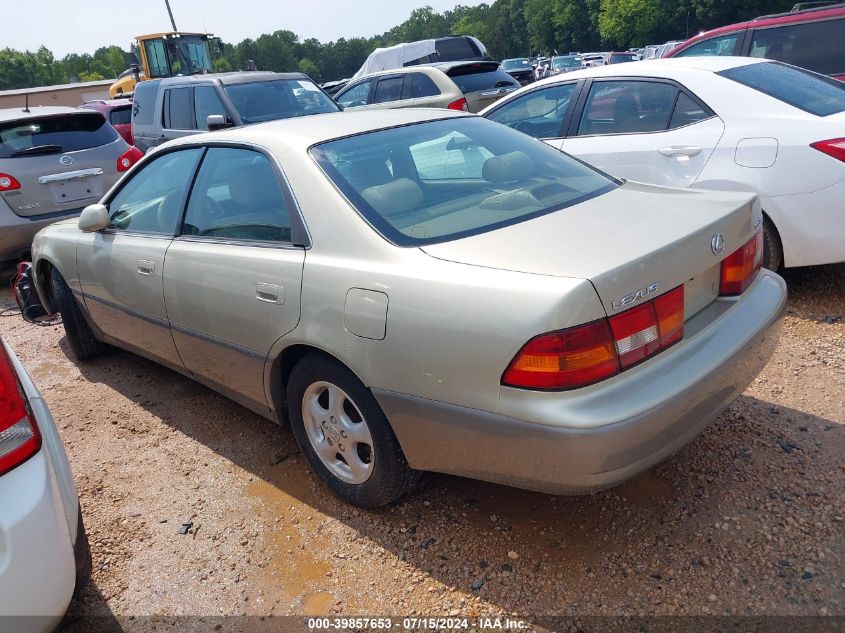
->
left=531, top=57, right=771, bottom=87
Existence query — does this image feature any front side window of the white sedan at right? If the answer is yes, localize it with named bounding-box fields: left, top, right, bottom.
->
left=487, top=83, right=575, bottom=138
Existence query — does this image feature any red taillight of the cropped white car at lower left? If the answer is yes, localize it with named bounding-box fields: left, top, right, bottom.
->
left=0, top=341, right=41, bottom=475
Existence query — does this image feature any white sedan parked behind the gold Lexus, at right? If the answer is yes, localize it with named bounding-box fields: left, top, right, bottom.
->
left=481, top=57, right=845, bottom=270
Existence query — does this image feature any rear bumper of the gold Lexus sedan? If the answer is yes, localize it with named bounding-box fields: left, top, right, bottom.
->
left=373, top=271, right=786, bottom=494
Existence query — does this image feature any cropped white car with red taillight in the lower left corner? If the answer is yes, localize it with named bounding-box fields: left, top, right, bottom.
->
left=0, top=339, right=91, bottom=633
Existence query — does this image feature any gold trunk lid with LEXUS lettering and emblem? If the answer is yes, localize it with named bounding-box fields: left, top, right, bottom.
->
left=423, top=183, right=762, bottom=318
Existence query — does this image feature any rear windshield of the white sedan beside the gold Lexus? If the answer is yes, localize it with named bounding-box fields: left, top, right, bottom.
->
left=719, top=62, right=845, bottom=116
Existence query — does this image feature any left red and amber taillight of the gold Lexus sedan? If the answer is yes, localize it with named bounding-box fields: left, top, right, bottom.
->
left=502, top=285, right=684, bottom=391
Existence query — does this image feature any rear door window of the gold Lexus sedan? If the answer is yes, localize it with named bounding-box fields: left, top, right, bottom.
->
left=182, top=147, right=291, bottom=242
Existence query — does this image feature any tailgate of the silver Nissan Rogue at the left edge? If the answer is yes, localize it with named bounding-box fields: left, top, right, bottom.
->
left=0, top=110, right=129, bottom=218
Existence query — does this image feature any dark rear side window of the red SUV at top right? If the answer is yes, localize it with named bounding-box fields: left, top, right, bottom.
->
left=749, top=18, right=845, bottom=75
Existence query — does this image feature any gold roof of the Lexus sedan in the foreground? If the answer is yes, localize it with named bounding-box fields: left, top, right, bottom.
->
left=167, top=108, right=468, bottom=151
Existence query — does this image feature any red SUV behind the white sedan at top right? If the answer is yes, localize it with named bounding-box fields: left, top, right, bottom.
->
left=666, top=4, right=845, bottom=80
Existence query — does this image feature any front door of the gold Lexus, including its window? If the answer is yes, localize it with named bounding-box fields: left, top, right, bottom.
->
left=76, top=148, right=203, bottom=367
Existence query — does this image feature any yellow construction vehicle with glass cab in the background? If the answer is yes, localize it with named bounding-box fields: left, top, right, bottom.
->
left=109, top=31, right=219, bottom=98
